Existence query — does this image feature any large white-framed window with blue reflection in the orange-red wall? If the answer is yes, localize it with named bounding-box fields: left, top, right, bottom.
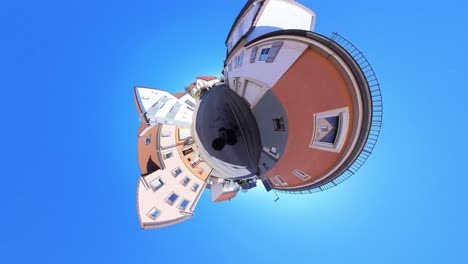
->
left=309, top=107, right=349, bottom=152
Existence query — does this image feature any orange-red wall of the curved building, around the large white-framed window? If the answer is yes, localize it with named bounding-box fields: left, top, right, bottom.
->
left=266, top=49, right=354, bottom=186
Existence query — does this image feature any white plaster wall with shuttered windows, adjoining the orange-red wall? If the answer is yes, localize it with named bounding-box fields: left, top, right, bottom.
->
left=228, top=39, right=307, bottom=89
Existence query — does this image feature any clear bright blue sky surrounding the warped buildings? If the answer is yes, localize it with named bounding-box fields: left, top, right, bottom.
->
left=0, top=0, right=468, bottom=263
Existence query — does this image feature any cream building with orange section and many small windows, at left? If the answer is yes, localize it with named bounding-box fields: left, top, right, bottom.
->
left=135, top=88, right=211, bottom=229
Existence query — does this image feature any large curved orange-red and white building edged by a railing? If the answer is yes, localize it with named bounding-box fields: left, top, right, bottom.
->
left=223, top=0, right=382, bottom=192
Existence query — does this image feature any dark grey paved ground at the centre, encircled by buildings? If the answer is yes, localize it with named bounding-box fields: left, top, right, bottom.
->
left=195, top=85, right=261, bottom=178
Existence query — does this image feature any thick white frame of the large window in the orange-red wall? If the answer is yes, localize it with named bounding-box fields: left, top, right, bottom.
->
left=309, top=107, right=349, bottom=152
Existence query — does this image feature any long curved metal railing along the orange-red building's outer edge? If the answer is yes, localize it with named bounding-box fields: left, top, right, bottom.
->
left=276, top=32, right=383, bottom=194
